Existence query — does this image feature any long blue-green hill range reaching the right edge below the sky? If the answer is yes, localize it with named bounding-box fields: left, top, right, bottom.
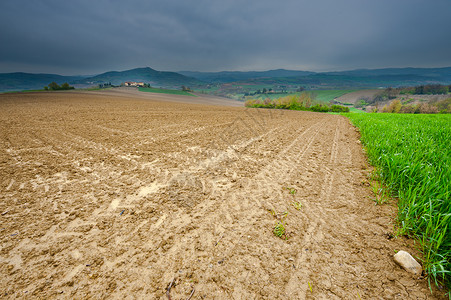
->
left=198, top=68, right=451, bottom=99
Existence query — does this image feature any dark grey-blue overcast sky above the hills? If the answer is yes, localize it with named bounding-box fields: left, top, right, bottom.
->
left=0, top=0, right=451, bottom=75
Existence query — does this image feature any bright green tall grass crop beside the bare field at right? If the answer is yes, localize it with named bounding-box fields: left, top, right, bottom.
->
left=345, top=114, right=451, bottom=297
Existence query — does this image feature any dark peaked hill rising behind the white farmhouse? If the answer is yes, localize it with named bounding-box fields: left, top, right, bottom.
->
left=76, top=67, right=203, bottom=88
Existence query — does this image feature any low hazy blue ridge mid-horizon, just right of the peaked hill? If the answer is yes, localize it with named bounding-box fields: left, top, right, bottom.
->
left=179, top=69, right=315, bottom=83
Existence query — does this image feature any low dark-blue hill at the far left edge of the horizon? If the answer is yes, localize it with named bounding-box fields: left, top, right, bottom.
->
left=0, top=72, right=83, bottom=92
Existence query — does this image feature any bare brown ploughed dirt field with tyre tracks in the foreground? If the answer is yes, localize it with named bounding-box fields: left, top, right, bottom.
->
left=0, top=93, right=446, bottom=299
